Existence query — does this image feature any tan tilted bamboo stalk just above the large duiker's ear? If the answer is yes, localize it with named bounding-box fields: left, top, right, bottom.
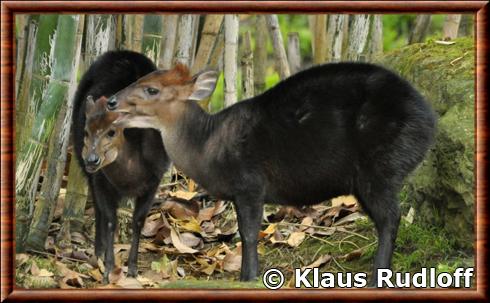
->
left=191, top=15, right=224, bottom=74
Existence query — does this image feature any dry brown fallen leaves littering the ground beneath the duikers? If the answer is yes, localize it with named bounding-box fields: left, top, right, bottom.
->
left=16, top=173, right=372, bottom=289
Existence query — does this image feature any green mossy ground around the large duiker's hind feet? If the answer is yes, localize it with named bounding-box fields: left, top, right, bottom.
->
left=163, top=220, right=474, bottom=288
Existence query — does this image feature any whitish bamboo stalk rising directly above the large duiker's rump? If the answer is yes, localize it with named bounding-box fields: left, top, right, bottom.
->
left=346, top=15, right=369, bottom=61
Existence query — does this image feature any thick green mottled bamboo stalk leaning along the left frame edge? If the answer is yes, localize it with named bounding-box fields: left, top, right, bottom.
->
left=15, top=15, right=81, bottom=252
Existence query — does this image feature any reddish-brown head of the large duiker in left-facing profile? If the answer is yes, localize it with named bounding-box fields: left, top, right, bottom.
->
left=107, top=64, right=218, bottom=130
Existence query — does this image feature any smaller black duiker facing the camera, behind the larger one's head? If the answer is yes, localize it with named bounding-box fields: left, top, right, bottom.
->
left=73, top=51, right=169, bottom=282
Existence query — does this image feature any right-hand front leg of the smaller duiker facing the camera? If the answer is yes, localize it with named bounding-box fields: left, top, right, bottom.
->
left=128, top=187, right=156, bottom=277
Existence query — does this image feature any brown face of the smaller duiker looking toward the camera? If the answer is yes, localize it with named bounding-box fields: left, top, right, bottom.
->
left=82, top=96, right=124, bottom=173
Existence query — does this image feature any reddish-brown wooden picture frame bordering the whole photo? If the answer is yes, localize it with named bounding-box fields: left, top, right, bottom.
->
left=0, top=1, right=489, bottom=301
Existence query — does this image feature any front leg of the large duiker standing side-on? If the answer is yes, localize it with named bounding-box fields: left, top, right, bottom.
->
left=235, top=199, right=264, bottom=281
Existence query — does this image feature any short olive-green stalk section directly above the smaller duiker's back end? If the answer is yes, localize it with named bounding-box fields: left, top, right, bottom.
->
left=142, top=15, right=163, bottom=63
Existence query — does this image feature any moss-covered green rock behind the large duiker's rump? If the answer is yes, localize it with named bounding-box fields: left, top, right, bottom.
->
left=377, top=38, right=475, bottom=248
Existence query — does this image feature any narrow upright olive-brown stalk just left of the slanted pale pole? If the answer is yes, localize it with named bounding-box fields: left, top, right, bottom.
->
left=253, top=15, right=267, bottom=94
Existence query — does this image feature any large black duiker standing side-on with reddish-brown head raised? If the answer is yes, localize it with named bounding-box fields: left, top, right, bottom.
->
left=108, top=63, right=435, bottom=283
